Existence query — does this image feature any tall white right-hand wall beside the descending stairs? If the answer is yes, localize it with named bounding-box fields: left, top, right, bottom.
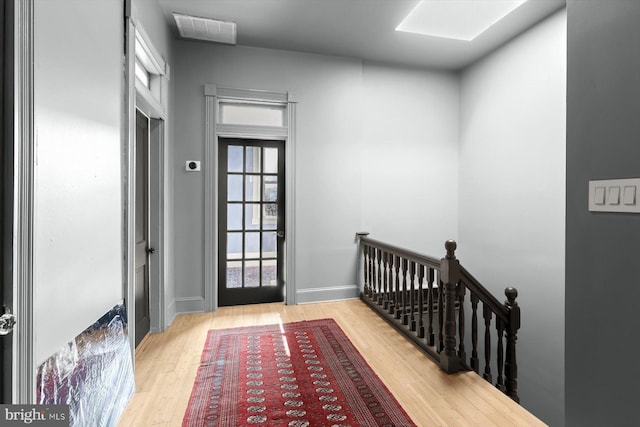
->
left=458, top=10, right=567, bottom=426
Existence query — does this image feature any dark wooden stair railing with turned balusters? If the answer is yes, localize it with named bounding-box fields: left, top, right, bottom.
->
left=356, top=232, right=520, bottom=402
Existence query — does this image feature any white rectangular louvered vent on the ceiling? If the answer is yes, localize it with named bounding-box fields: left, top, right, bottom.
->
left=173, top=13, right=237, bottom=45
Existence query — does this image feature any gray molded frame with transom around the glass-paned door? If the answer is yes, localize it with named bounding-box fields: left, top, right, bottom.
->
left=203, top=84, right=297, bottom=311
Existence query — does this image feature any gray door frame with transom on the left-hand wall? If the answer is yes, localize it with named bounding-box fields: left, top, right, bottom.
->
left=123, top=11, right=170, bottom=358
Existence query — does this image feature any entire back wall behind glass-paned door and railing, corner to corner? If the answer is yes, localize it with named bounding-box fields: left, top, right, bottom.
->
left=173, top=41, right=457, bottom=311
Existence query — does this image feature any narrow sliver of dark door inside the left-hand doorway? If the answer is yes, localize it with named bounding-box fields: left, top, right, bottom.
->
left=134, top=110, right=153, bottom=346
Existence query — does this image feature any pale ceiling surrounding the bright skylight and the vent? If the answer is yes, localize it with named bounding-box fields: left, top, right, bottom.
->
left=159, top=0, right=566, bottom=70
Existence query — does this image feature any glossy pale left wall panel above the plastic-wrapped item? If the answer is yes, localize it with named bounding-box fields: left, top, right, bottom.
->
left=34, top=0, right=123, bottom=365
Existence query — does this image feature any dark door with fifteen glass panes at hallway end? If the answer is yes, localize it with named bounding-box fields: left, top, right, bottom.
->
left=218, top=138, right=285, bottom=306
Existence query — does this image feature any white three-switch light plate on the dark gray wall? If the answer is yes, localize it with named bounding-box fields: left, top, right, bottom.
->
left=589, top=178, right=640, bottom=213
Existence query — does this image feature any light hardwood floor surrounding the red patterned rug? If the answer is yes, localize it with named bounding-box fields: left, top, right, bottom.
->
left=118, top=300, right=545, bottom=427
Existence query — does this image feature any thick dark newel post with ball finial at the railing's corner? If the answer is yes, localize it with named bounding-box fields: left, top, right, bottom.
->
left=440, top=240, right=463, bottom=373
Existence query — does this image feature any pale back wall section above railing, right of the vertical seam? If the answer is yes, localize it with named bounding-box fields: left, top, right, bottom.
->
left=362, top=64, right=459, bottom=258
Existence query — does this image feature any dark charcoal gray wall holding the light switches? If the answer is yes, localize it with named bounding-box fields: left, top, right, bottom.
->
left=565, top=0, right=640, bottom=427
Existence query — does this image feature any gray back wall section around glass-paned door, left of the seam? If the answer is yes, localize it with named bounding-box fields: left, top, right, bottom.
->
left=174, top=45, right=362, bottom=312
